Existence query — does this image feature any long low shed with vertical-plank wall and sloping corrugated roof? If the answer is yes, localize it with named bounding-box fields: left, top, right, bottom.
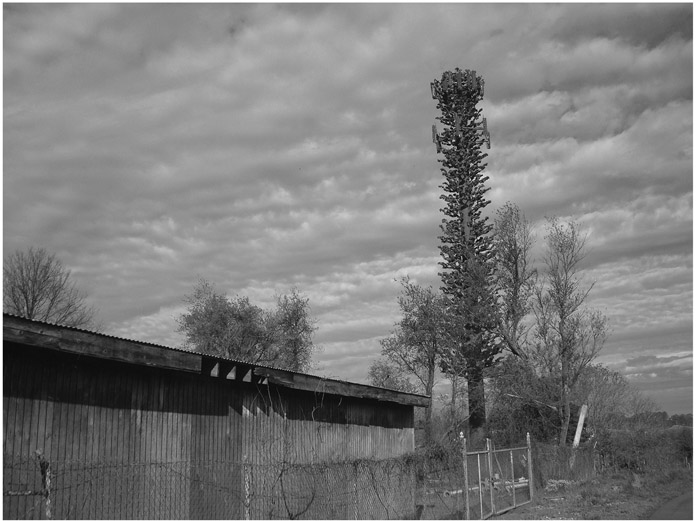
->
left=3, top=314, right=428, bottom=519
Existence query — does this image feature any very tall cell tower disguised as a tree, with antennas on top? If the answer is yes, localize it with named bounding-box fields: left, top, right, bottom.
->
left=431, top=68, right=501, bottom=434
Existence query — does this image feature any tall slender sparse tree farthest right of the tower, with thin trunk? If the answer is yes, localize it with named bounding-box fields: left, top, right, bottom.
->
left=533, top=218, right=608, bottom=445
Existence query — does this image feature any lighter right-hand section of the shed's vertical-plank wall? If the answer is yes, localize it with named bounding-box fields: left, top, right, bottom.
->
left=242, top=386, right=413, bottom=519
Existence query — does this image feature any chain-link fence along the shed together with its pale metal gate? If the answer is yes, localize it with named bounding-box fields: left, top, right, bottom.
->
left=3, top=436, right=531, bottom=519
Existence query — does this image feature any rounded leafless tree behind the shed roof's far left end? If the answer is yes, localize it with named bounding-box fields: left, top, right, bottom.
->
left=3, top=247, right=98, bottom=328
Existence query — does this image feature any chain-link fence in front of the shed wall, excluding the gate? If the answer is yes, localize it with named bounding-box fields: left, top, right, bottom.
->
left=3, top=457, right=415, bottom=519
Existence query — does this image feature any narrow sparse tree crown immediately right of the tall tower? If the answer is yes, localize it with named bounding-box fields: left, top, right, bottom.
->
left=493, top=202, right=537, bottom=357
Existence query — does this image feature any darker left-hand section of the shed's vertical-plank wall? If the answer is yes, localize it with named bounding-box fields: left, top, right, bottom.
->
left=3, top=345, right=241, bottom=519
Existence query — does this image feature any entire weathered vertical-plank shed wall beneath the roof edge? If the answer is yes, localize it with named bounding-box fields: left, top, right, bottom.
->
left=3, top=342, right=413, bottom=519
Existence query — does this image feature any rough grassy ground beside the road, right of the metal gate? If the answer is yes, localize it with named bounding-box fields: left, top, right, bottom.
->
left=496, top=471, right=693, bottom=519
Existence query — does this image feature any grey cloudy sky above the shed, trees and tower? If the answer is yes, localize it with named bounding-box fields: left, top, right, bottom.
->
left=3, top=4, right=693, bottom=413
